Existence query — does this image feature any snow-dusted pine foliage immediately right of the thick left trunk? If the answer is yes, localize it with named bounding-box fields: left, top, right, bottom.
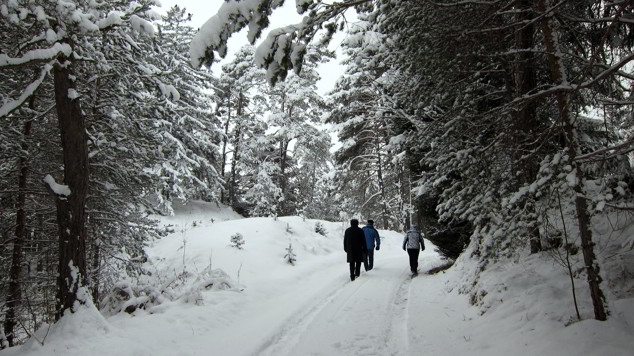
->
left=80, top=3, right=165, bottom=303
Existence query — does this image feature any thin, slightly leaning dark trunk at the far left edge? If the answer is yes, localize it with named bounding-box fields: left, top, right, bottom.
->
left=4, top=116, right=33, bottom=346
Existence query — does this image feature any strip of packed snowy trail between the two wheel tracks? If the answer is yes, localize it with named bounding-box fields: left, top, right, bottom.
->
left=256, top=255, right=420, bottom=355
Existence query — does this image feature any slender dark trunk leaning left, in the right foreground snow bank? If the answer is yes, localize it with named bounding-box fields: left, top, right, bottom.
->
left=536, top=0, right=608, bottom=320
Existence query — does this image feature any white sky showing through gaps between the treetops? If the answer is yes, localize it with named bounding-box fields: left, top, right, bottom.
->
left=160, top=0, right=343, bottom=95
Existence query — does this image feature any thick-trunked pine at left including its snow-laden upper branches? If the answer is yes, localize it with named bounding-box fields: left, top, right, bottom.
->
left=0, top=1, right=163, bottom=334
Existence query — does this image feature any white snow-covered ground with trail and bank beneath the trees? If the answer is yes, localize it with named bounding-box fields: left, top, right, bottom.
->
left=0, top=203, right=634, bottom=356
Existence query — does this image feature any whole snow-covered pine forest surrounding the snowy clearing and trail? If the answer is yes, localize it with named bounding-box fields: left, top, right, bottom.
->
left=0, top=0, right=634, bottom=347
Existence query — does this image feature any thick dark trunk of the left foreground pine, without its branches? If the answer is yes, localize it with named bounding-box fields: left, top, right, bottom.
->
left=53, top=58, right=89, bottom=319
